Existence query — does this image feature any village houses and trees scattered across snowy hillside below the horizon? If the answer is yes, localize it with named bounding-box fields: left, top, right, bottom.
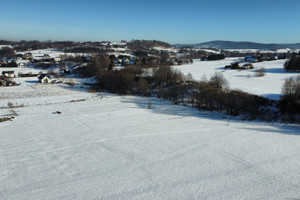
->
left=0, top=40, right=293, bottom=86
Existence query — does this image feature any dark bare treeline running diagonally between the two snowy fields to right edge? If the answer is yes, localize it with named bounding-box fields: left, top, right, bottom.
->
left=77, top=61, right=300, bottom=123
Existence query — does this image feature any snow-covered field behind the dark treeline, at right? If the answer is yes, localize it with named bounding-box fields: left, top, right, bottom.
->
left=174, top=58, right=299, bottom=99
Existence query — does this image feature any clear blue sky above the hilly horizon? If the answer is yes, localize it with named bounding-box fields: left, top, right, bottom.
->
left=0, top=0, right=300, bottom=44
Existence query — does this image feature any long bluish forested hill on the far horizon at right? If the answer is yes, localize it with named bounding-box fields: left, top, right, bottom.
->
left=174, top=40, right=300, bottom=50
